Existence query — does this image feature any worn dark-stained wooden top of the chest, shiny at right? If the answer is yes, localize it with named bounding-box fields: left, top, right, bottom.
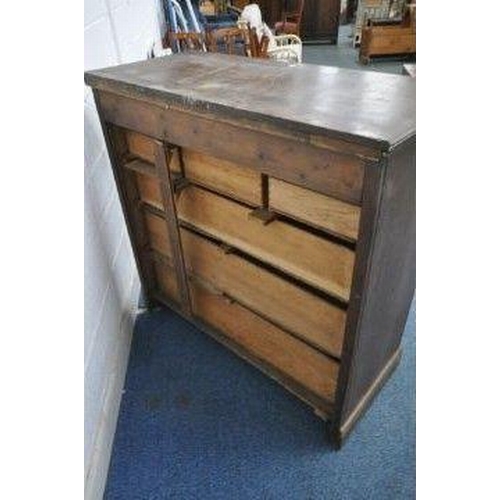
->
left=85, top=54, right=415, bottom=150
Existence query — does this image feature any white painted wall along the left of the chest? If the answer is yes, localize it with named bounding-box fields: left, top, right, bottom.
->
left=84, top=0, right=164, bottom=500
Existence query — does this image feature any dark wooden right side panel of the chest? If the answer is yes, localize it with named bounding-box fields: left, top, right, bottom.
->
left=336, top=138, right=415, bottom=438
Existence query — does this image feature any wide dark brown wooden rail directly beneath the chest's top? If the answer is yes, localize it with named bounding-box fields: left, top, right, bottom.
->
left=99, top=91, right=364, bottom=204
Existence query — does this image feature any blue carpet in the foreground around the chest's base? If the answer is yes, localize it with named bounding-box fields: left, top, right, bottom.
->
left=104, top=298, right=415, bottom=500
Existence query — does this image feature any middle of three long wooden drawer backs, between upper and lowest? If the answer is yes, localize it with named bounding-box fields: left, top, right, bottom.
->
left=181, top=229, right=346, bottom=356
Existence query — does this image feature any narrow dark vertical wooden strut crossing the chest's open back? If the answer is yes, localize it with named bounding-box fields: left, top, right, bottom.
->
left=151, top=141, right=192, bottom=316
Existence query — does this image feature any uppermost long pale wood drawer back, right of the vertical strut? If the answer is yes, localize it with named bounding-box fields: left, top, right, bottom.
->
left=177, top=186, right=354, bottom=301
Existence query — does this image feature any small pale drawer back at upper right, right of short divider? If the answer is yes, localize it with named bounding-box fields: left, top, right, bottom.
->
left=269, top=178, right=361, bottom=241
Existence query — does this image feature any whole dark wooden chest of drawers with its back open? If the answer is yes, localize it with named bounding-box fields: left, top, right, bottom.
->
left=85, top=54, right=415, bottom=447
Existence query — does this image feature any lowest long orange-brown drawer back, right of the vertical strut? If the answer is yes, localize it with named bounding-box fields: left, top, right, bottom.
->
left=191, top=282, right=338, bottom=401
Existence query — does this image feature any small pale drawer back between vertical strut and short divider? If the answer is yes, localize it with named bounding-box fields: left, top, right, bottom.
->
left=182, top=149, right=261, bottom=205
